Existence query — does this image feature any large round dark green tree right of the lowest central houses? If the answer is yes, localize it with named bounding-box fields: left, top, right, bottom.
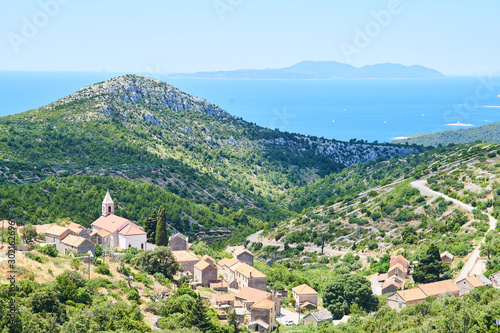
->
left=323, top=274, right=378, bottom=319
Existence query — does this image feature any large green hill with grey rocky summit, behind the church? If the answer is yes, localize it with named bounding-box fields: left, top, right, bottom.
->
left=0, top=75, right=421, bottom=208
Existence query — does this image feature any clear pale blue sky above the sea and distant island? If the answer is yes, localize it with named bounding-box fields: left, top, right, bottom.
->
left=0, top=0, right=500, bottom=75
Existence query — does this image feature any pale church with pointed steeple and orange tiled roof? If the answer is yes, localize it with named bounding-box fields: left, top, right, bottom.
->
left=90, top=191, right=151, bottom=250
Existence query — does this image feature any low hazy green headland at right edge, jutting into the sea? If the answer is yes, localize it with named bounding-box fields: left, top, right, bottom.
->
left=392, top=122, right=500, bottom=147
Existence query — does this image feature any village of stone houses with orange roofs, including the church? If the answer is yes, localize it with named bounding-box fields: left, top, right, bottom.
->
left=3, top=192, right=500, bottom=332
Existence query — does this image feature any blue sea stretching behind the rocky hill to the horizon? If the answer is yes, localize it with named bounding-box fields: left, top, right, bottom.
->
left=0, top=72, right=500, bottom=142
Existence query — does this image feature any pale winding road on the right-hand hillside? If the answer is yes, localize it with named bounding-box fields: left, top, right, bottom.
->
left=410, top=180, right=497, bottom=281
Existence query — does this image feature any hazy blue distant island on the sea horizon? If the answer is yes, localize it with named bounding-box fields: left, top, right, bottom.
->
left=167, top=61, right=444, bottom=80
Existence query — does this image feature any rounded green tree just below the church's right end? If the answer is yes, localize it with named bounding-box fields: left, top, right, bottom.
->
left=131, top=246, right=182, bottom=279
